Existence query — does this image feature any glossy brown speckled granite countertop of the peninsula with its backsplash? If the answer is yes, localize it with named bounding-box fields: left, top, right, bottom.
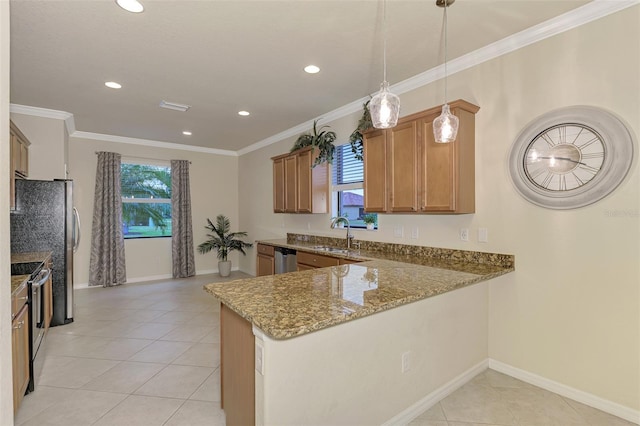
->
left=204, top=240, right=515, bottom=339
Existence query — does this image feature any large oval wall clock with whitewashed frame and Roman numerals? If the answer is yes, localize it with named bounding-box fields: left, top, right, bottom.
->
left=509, top=106, right=634, bottom=209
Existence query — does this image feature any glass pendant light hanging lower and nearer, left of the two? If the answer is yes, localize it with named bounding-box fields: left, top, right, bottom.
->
left=369, top=0, right=400, bottom=129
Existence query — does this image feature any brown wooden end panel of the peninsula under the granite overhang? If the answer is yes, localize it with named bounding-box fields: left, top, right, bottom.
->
left=220, top=304, right=256, bottom=426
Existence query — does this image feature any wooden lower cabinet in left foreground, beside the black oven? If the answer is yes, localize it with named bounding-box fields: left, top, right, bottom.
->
left=11, top=283, right=30, bottom=413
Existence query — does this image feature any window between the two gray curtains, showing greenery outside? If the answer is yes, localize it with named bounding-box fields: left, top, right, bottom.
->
left=120, top=162, right=171, bottom=239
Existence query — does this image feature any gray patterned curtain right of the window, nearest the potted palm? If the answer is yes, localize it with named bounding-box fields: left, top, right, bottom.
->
left=171, top=160, right=196, bottom=278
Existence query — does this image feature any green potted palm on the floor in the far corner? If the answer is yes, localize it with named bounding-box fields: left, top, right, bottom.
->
left=198, top=214, right=253, bottom=277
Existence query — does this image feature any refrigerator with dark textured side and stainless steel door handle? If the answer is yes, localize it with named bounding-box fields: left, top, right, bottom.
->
left=11, top=179, right=80, bottom=326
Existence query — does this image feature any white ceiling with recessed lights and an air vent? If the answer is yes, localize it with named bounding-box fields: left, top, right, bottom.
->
left=10, top=0, right=589, bottom=151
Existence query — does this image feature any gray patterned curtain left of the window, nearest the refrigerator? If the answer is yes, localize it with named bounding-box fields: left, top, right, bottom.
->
left=89, top=152, right=127, bottom=287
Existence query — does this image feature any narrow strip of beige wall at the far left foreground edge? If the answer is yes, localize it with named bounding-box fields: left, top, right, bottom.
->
left=0, top=1, right=13, bottom=425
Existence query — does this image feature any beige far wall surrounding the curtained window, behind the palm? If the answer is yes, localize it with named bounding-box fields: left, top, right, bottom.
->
left=69, top=137, right=240, bottom=285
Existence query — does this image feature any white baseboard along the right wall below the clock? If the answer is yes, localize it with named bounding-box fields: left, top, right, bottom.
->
left=489, top=359, right=640, bottom=424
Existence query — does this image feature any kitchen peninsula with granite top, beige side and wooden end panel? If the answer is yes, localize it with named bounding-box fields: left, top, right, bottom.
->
left=205, top=238, right=514, bottom=424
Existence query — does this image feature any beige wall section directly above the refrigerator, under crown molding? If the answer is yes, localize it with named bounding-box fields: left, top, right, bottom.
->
left=11, top=113, right=69, bottom=180
